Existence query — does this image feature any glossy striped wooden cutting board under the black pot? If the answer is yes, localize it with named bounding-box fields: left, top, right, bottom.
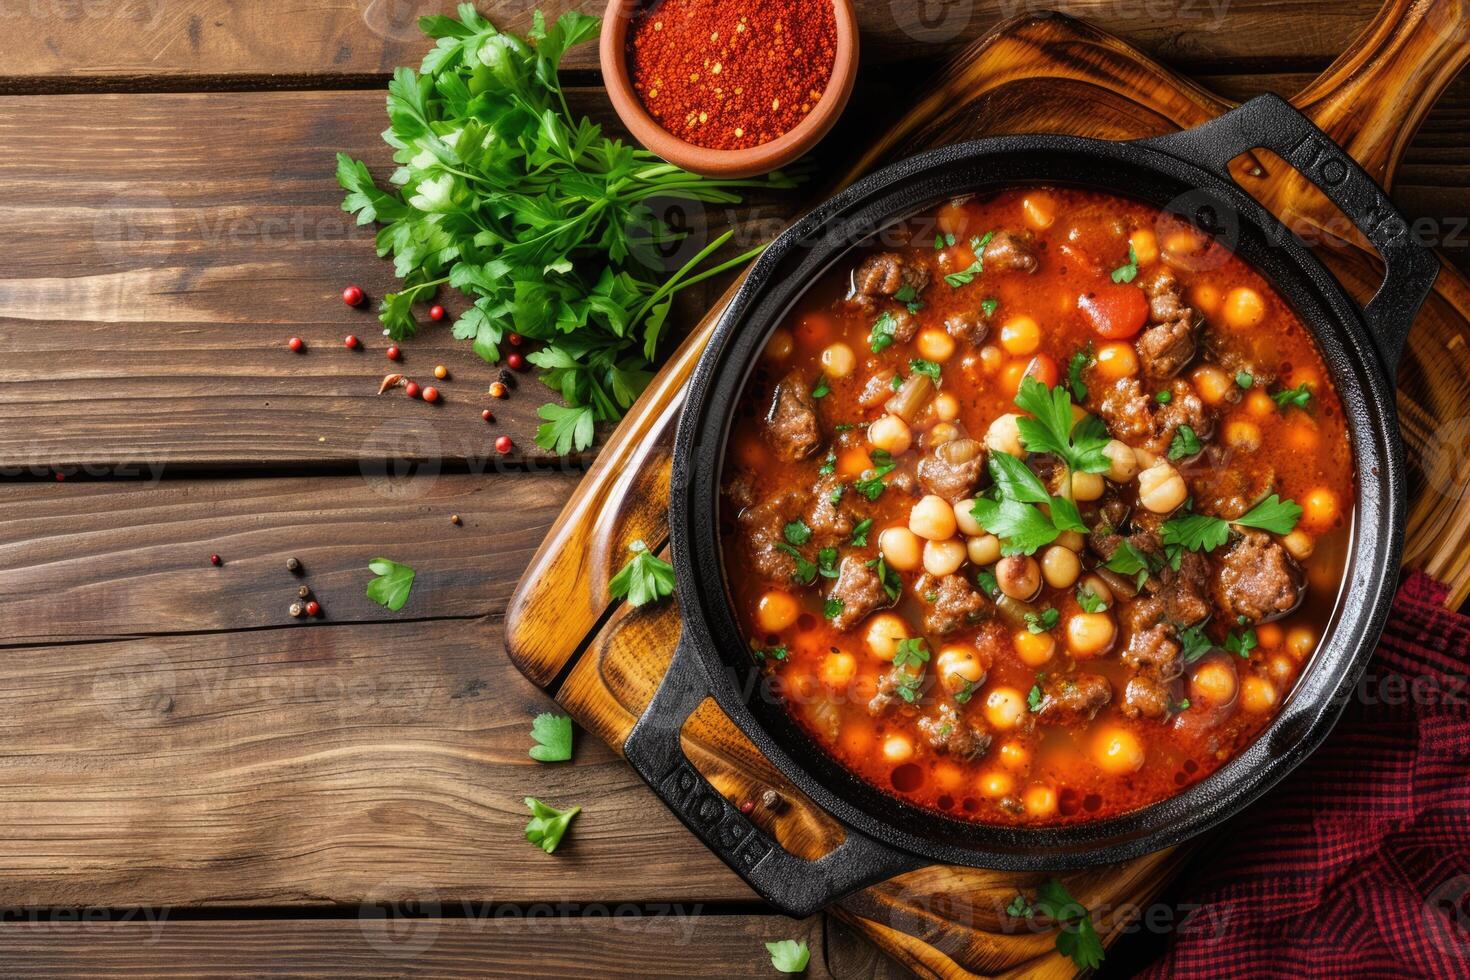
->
left=506, top=0, right=1470, bottom=977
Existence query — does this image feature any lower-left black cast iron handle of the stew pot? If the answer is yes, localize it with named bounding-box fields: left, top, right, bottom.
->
left=623, top=638, right=928, bottom=918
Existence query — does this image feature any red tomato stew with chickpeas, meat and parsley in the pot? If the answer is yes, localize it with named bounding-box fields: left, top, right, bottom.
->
left=722, top=187, right=1354, bottom=824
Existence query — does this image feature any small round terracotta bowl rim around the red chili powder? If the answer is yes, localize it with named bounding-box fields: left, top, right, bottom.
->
left=598, top=0, right=857, bottom=178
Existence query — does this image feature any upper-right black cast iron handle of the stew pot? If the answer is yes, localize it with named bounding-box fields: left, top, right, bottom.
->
left=1142, top=96, right=1439, bottom=378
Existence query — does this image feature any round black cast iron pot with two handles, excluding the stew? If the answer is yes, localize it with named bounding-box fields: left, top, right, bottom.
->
left=623, top=96, right=1439, bottom=915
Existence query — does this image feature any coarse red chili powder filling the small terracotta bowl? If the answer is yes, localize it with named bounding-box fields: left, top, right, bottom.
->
left=628, top=0, right=836, bottom=150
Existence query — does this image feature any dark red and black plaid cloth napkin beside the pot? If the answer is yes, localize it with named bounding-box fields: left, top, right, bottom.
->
left=1148, top=573, right=1470, bottom=980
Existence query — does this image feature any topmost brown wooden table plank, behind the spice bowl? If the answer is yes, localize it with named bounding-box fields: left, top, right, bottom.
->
left=0, top=0, right=1377, bottom=93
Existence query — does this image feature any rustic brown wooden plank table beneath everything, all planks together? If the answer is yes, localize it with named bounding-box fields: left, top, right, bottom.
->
left=0, top=0, right=1470, bottom=977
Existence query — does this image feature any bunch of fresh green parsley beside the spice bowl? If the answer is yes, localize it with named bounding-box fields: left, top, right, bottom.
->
left=337, top=3, right=794, bottom=453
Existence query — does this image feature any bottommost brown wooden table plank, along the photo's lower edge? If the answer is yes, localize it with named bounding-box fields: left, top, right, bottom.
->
left=0, top=916, right=834, bottom=980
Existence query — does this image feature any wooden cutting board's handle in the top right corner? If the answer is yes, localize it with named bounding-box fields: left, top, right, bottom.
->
left=1291, top=0, right=1470, bottom=190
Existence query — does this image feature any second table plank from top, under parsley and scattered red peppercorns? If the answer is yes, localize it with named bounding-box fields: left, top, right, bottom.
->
left=0, top=76, right=1470, bottom=476
